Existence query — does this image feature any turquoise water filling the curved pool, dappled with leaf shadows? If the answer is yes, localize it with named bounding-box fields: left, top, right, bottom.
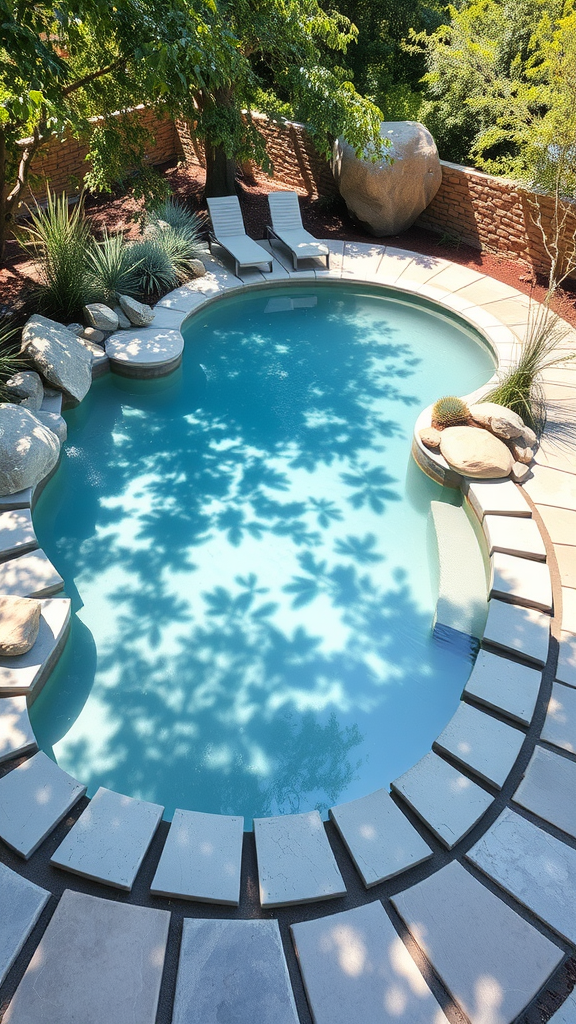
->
left=31, top=284, right=493, bottom=827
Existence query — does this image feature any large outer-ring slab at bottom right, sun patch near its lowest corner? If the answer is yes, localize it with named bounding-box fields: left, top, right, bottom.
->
left=393, top=861, right=564, bottom=1024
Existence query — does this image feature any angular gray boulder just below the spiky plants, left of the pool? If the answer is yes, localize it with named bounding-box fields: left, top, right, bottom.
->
left=22, top=315, right=92, bottom=401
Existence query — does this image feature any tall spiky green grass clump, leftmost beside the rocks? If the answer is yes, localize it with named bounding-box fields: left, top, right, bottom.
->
left=18, top=189, right=90, bottom=322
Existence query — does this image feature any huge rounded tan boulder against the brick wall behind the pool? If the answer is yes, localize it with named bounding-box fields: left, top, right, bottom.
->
left=332, top=121, right=442, bottom=238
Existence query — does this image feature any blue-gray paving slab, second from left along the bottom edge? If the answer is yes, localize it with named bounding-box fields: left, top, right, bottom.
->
left=172, top=918, right=298, bottom=1024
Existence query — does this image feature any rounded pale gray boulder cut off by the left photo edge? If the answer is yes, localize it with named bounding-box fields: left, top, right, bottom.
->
left=0, top=402, right=60, bottom=495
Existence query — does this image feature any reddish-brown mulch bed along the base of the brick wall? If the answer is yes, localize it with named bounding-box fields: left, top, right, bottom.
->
left=0, top=159, right=576, bottom=327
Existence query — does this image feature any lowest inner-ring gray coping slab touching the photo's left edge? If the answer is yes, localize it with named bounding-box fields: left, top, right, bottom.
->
left=0, top=751, right=86, bottom=860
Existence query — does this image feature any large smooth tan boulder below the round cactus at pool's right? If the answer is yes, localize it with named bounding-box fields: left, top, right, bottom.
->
left=440, top=427, right=515, bottom=480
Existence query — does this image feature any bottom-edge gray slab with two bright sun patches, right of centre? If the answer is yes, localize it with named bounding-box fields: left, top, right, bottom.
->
left=290, top=902, right=447, bottom=1024
